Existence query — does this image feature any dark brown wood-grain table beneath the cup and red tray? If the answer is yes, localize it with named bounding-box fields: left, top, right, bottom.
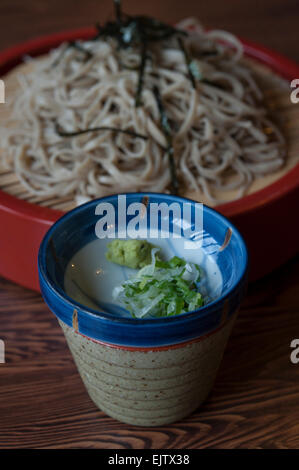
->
left=0, top=0, right=299, bottom=449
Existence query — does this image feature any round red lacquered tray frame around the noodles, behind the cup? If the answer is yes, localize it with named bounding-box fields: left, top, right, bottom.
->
left=0, top=28, right=299, bottom=290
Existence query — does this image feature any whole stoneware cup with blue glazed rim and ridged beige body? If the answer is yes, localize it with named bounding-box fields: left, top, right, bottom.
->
left=38, top=193, right=247, bottom=426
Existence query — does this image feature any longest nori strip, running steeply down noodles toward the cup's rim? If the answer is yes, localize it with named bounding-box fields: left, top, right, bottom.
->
left=153, top=86, right=179, bottom=194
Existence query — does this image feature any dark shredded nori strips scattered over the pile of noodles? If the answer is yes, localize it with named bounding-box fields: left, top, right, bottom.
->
left=53, top=0, right=196, bottom=194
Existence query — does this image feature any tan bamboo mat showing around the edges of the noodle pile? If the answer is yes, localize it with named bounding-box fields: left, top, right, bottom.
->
left=0, top=54, right=299, bottom=211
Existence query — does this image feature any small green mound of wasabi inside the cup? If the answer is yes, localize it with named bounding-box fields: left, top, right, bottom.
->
left=106, top=240, right=155, bottom=269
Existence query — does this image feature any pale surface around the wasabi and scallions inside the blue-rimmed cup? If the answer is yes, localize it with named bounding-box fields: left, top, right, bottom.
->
left=64, top=238, right=222, bottom=318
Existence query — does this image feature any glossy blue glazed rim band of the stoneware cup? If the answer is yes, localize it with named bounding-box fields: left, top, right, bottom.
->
left=38, top=192, right=248, bottom=347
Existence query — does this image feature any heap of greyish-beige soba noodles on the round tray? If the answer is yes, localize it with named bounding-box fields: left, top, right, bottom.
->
left=1, top=15, right=285, bottom=202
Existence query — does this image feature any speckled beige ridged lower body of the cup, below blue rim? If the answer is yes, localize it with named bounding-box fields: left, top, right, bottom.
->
left=59, top=315, right=235, bottom=426
